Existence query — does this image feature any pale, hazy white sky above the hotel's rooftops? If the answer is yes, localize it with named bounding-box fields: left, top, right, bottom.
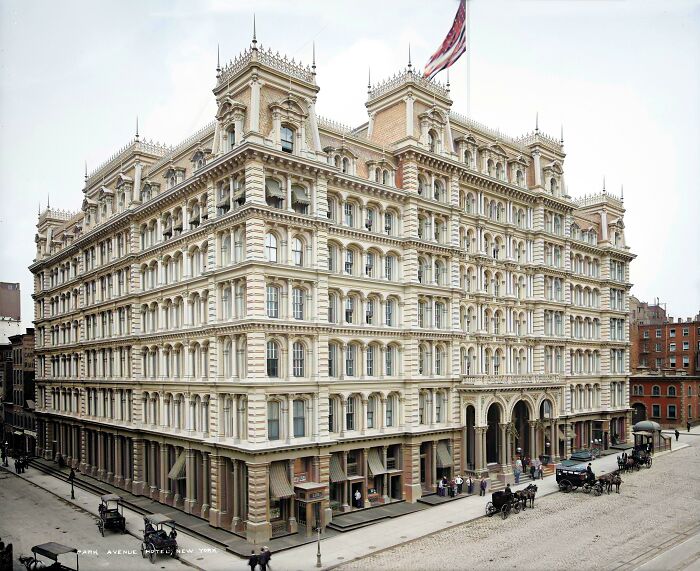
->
left=0, top=0, right=700, bottom=326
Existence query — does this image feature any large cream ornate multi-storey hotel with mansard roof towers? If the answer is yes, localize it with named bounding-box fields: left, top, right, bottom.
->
left=31, top=32, right=634, bottom=542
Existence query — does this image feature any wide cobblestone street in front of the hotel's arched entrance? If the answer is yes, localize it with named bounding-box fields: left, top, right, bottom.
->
left=339, top=436, right=700, bottom=570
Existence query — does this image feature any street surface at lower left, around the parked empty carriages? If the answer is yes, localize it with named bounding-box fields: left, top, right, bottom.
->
left=0, top=470, right=185, bottom=571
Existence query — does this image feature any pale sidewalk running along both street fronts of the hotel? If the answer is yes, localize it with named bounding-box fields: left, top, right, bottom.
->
left=5, top=436, right=688, bottom=571
